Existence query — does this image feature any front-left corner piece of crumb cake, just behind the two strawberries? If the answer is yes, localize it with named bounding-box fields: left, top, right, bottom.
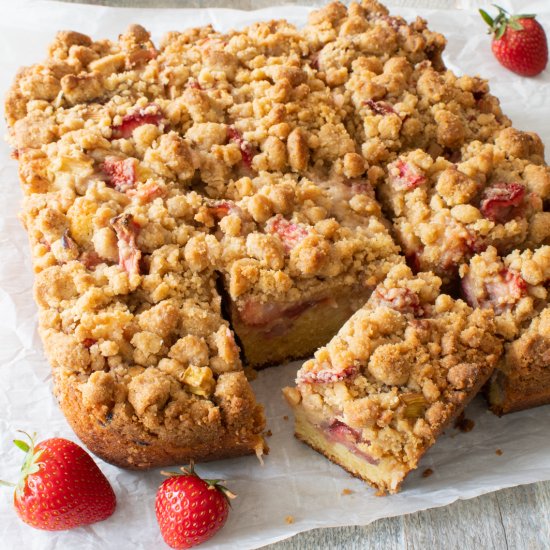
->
left=35, top=256, right=265, bottom=469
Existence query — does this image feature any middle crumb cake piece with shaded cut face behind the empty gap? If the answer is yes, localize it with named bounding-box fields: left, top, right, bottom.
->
left=209, top=173, right=403, bottom=366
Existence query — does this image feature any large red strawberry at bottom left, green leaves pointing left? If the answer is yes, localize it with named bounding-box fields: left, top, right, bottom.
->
left=0, top=432, right=116, bottom=531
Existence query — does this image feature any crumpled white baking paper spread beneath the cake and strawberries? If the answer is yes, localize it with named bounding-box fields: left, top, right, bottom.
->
left=0, top=0, right=550, bottom=550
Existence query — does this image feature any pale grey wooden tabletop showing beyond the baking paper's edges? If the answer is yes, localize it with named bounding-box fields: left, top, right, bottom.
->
left=60, top=0, right=550, bottom=550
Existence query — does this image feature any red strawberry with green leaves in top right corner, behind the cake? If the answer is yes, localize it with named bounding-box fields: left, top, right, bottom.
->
left=479, top=6, right=548, bottom=76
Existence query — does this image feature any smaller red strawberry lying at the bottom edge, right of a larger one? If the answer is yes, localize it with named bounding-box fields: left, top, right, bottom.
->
left=155, top=464, right=235, bottom=549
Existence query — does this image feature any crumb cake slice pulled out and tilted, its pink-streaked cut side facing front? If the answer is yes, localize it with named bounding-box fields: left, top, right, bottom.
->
left=284, top=265, right=501, bottom=494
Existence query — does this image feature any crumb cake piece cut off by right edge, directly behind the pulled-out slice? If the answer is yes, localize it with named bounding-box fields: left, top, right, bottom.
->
left=461, top=246, right=550, bottom=414
